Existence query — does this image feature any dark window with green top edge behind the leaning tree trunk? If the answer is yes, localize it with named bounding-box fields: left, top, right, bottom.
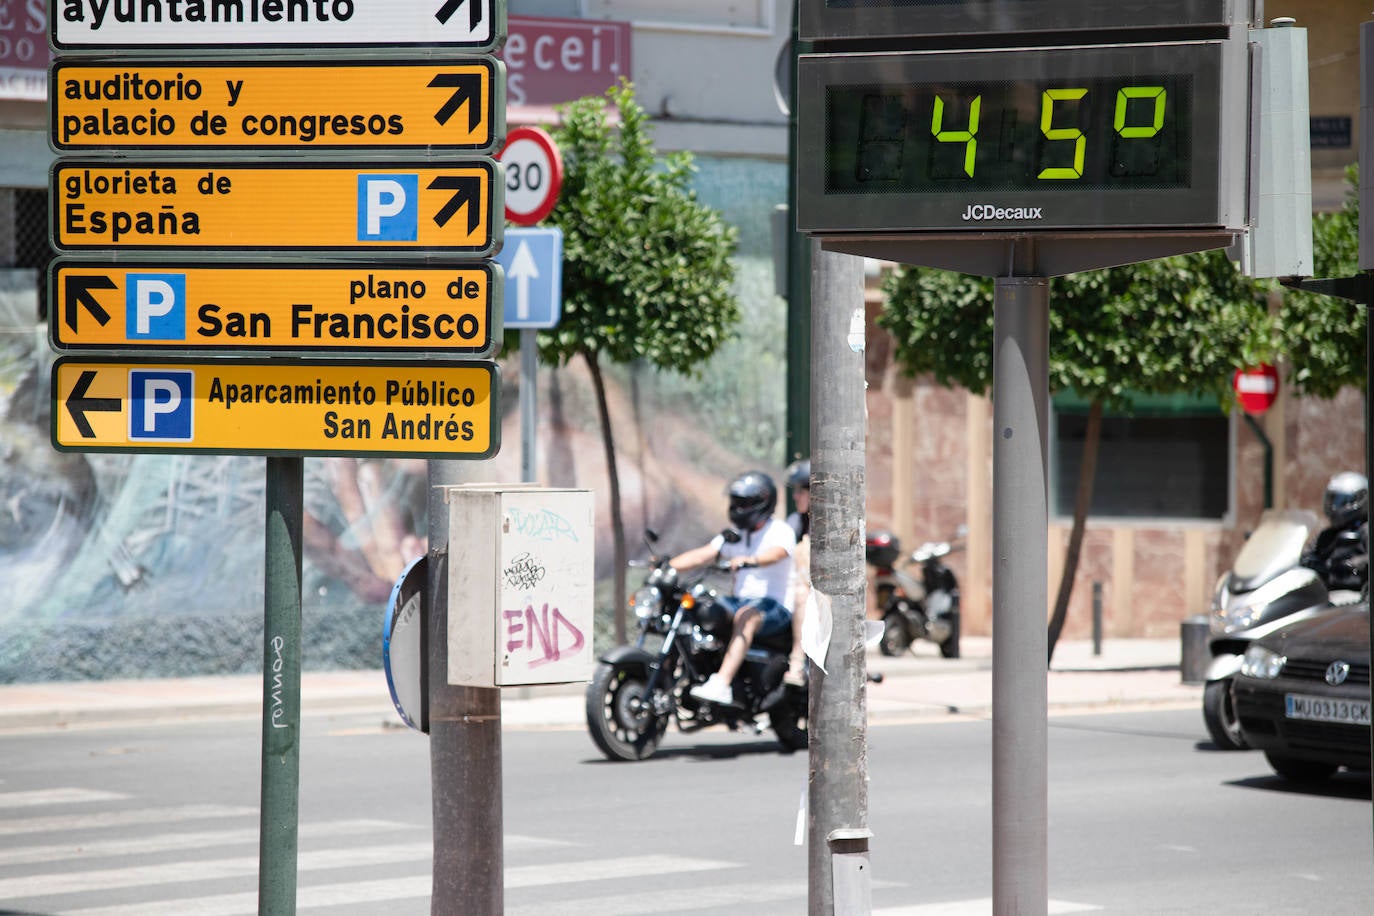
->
left=1051, top=396, right=1231, bottom=520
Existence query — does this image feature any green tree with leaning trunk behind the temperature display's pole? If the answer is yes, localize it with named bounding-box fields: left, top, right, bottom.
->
left=878, top=251, right=1274, bottom=658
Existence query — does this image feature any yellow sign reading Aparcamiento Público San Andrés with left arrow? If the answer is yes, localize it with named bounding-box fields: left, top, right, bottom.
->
left=52, top=357, right=500, bottom=459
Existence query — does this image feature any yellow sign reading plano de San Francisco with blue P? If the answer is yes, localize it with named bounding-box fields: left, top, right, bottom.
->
left=48, top=258, right=502, bottom=357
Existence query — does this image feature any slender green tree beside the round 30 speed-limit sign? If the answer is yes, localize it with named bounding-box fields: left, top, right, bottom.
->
left=539, top=81, right=739, bottom=641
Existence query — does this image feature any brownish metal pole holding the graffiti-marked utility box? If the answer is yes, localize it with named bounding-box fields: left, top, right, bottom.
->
left=427, top=459, right=504, bottom=916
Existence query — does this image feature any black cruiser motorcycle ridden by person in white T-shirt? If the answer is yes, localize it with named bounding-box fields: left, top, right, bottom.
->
left=587, top=530, right=808, bottom=761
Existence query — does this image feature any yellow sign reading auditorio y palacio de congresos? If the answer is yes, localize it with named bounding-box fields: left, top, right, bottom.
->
left=48, top=58, right=506, bottom=152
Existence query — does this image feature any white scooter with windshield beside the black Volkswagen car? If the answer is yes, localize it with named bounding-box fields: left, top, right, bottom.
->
left=1202, top=509, right=1360, bottom=751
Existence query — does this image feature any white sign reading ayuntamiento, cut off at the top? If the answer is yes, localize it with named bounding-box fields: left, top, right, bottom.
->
left=49, top=0, right=506, bottom=52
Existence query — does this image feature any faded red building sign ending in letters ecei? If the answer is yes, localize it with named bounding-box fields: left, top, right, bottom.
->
left=500, top=16, right=631, bottom=114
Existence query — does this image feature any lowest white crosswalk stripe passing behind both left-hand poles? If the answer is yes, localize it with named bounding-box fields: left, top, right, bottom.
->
left=58, top=856, right=739, bottom=916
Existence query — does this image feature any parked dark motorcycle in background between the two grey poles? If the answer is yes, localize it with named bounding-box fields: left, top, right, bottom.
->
left=864, top=526, right=966, bottom=658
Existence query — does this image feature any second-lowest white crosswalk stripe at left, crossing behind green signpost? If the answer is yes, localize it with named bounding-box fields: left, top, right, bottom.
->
left=0, top=842, right=431, bottom=900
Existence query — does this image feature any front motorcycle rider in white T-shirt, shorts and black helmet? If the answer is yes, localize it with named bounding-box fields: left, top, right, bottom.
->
left=669, top=471, right=797, bottom=706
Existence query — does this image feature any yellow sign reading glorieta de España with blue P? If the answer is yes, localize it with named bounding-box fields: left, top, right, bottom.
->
left=56, top=158, right=504, bottom=257
